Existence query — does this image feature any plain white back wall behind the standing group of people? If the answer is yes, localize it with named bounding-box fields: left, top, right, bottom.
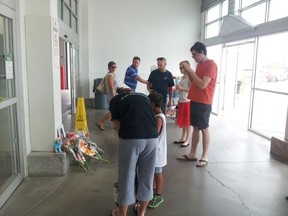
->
left=80, top=0, right=201, bottom=97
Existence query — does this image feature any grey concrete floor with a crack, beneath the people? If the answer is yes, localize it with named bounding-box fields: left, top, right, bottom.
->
left=0, top=109, right=288, bottom=216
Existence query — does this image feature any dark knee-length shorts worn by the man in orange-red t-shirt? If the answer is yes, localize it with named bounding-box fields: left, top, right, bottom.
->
left=190, top=101, right=212, bottom=130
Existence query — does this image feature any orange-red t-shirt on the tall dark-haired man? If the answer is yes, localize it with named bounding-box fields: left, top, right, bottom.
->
left=188, top=60, right=217, bottom=104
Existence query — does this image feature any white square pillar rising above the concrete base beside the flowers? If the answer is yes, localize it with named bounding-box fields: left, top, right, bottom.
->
left=25, top=0, right=62, bottom=152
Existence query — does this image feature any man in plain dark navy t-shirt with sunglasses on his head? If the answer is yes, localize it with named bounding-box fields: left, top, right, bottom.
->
left=147, top=57, right=174, bottom=114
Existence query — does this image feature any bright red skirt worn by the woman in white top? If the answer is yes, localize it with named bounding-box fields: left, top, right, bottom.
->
left=176, top=101, right=191, bottom=128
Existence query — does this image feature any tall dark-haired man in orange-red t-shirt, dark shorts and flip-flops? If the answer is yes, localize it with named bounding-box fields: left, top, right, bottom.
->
left=177, top=42, right=217, bottom=167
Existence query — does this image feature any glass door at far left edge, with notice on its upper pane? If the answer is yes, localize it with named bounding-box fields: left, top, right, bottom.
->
left=0, top=14, right=24, bottom=207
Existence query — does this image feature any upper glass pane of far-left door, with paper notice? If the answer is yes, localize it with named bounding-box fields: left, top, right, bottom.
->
left=0, top=16, right=15, bottom=102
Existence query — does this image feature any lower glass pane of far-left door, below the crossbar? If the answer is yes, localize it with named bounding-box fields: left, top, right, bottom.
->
left=0, top=105, right=20, bottom=192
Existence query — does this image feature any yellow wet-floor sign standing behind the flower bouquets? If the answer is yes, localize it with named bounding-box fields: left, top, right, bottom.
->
left=75, top=97, right=89, bottom=134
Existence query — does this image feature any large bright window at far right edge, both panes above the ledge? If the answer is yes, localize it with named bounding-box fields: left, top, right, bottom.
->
left=251, top=33, right=288, bottom=137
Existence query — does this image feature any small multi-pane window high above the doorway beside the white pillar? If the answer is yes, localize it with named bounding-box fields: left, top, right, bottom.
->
left=58, top=0, right=78, bottom=33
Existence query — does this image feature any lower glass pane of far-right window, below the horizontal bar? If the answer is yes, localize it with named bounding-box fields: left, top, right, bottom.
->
left=251, top=90, right=288, bottom=138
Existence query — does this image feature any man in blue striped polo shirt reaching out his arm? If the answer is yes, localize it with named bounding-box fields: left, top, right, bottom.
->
left=124, top=56, right=148, bottom=92
